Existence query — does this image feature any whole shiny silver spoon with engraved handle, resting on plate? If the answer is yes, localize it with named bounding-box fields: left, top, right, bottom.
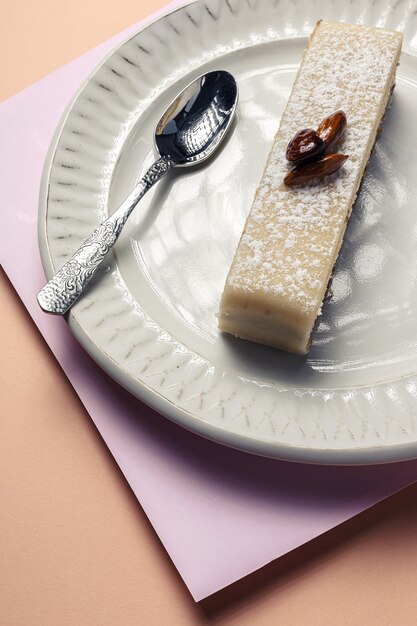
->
left=37, top=70, right=238, bottom=315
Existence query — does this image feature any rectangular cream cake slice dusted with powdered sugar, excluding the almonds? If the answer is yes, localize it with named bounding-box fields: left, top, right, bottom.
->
left=219, top=22, right=402, bottom=354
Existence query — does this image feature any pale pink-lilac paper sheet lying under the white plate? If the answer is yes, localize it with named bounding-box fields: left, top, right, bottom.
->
left=0, top=1, right=417, bottom=600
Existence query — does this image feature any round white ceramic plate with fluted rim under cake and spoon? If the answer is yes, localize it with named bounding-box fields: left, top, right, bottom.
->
left=39, top=0, right=417, bottom=463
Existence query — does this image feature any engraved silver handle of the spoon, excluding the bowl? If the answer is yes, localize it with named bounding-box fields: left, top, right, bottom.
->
left=37, top=156, right=175, bottom=315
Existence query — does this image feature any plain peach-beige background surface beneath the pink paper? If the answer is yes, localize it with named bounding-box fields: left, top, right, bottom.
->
left=0, top=0, right=417, bottom=626
